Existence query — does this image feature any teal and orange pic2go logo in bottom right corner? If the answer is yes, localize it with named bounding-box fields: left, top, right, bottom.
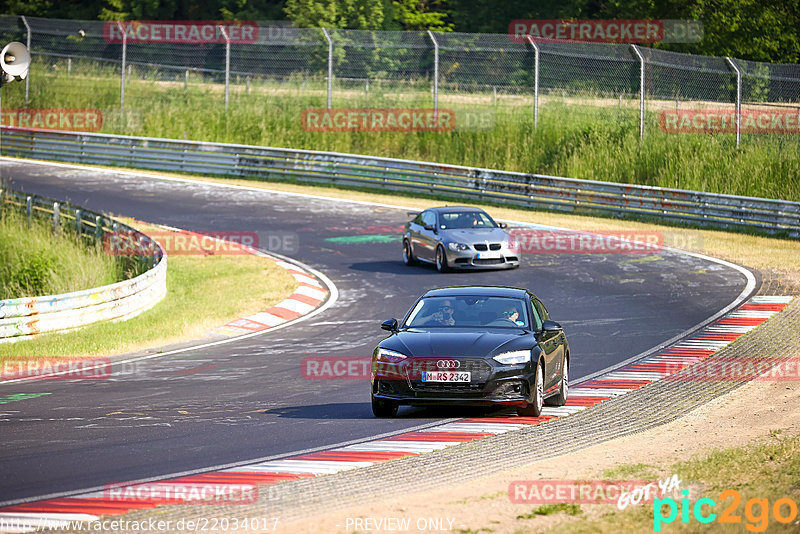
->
left=653, top=489, right=797, bottom=532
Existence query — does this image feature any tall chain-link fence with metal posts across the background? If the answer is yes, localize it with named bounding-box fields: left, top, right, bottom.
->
left=0, top=16, right=800, bottom=144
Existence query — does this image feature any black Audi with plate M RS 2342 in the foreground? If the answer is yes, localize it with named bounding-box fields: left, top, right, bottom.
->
left=371, top=286, right=570, bottom=417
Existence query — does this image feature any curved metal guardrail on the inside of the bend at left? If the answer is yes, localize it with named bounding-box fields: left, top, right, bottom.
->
left=0, top=190, right=167, bottom=342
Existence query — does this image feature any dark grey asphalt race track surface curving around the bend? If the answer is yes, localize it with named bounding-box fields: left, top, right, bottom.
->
left=0, top=160, right=746, bottom=503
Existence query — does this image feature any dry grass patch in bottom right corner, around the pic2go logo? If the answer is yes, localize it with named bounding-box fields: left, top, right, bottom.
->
left=536, top=430, right=800, bottom=534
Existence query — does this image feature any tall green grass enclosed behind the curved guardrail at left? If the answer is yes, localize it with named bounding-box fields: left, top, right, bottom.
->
left=0, top=209, right=126, bottom=300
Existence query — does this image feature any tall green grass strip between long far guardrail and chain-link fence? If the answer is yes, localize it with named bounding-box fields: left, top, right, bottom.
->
left=3, top=63, right=800, bottom=200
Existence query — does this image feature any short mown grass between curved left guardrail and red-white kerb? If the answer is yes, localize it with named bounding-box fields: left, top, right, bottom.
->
left=0, top=220, right=297, bottom=362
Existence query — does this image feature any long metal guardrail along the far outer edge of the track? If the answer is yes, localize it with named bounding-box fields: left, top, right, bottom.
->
left=2, top=128, right=800, bottom=238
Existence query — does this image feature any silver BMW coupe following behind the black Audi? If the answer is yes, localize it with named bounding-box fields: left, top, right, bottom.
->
left=403, top=206, right=519, bottom=272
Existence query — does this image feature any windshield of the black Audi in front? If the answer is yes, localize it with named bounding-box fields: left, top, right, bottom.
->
left=403, top=296, right=530, bottom=328
